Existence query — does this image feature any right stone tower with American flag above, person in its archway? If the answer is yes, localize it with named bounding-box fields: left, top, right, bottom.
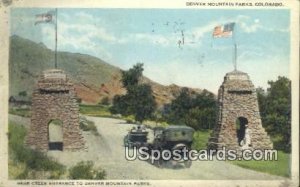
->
left=208, top=70, right=273, bottom=150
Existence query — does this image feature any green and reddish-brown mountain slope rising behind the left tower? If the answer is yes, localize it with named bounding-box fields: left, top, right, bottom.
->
left=9, top=35, right=201, bottom=106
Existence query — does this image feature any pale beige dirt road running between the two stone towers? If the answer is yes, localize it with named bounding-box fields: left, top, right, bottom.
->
left=10, top=116, right=283, bottom=180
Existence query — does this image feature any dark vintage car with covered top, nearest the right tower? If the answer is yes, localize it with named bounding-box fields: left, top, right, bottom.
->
left=148, top=125, right=195, bottom=168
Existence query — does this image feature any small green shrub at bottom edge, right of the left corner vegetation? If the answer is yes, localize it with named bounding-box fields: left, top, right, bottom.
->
left=69, top=161, right=106, bottom=180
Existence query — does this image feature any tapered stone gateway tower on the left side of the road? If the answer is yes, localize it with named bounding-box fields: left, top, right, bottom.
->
left=26, top=69, right=84, bottom=151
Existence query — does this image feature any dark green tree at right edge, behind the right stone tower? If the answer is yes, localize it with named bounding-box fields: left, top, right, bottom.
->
left=257, top=76, right=291, bottom=152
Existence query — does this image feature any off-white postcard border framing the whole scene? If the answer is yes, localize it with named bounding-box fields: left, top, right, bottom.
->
left=0, top=0, right=299, bottom=187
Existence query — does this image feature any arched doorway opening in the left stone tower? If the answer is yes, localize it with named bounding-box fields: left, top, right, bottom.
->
left=48, top=119, right=63, bottom=151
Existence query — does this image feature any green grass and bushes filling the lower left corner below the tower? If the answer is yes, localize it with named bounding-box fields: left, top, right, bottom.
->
left=8, top=122, right=106, bottom=179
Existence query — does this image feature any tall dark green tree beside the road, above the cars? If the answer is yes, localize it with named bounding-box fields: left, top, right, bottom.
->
left=111, top=63, right=156, bottom=122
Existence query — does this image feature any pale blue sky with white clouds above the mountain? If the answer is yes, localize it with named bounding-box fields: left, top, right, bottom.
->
left=10, top=8, right=290, bottom=93
